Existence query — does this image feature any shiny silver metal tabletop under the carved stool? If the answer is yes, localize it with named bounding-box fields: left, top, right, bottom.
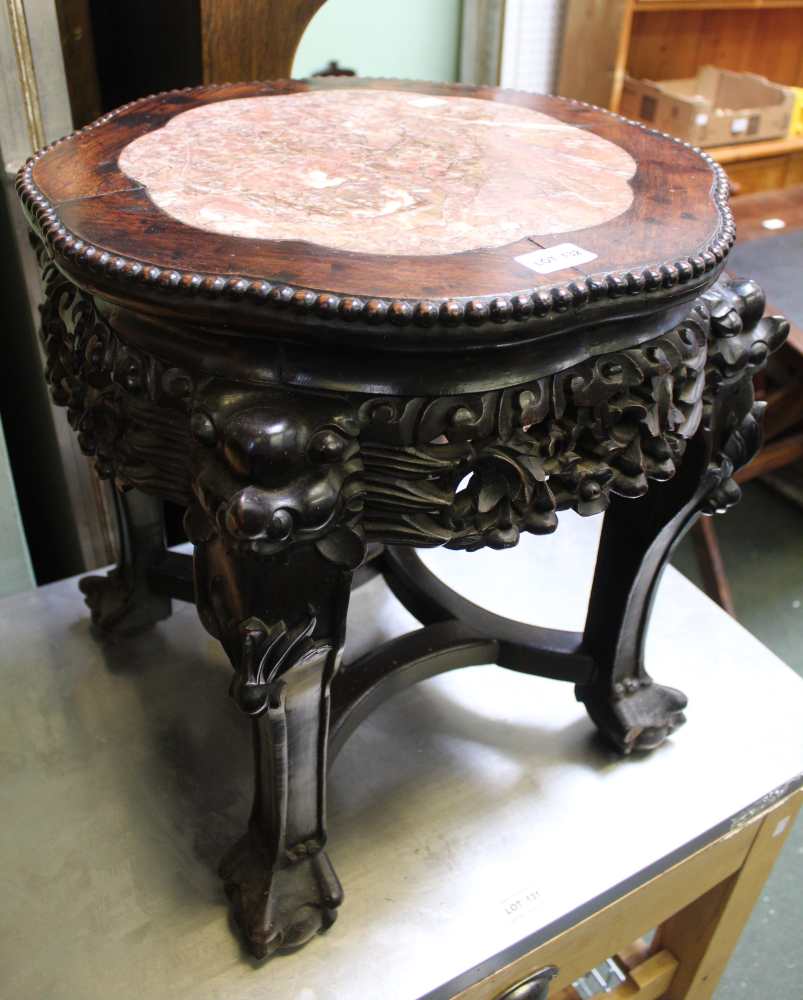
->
left=0, top=515, right=803, bottom=1000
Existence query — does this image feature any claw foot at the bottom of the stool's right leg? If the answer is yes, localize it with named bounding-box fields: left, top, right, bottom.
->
left=577, top=677, right=687, bottom=754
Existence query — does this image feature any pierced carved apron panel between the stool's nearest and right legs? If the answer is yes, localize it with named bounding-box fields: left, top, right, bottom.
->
left=360, top=305, right=708, bottom=549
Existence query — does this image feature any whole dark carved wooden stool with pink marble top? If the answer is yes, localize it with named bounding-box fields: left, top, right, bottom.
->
left=19, top=79, right=787, bottom=956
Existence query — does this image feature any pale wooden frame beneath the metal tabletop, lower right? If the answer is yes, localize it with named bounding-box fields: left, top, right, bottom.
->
left=462, top=789, right=803, bottom=1000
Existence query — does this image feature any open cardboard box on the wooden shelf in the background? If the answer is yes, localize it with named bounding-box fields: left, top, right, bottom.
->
left=619, top=66, right=794, bottom=146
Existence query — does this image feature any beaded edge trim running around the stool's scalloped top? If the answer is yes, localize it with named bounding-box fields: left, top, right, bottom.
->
left=16, top=78, right=736, bottom=327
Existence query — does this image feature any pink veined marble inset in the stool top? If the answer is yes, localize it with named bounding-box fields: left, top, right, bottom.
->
left=119, top=88, right=636, bottom=255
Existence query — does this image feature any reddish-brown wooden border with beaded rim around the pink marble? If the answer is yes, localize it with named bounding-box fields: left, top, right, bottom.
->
left=21, top=78, right=733, bottom=339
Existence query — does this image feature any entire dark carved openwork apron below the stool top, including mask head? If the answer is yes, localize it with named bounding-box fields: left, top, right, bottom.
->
left=36, top=245, right=787, bottom=565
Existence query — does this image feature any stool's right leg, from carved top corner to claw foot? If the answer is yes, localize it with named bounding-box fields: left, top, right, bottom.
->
left=576, top=281, right=788, bottom=753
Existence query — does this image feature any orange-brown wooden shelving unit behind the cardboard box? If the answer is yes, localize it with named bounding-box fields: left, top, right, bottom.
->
left=558, top=0, right=803, bottom=193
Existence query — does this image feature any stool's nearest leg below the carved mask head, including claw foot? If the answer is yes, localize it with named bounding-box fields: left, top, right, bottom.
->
left=195, top=536, right=352, bottom=958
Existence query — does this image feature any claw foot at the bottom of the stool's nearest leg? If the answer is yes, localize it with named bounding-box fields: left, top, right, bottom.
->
left=220, top=835, right=343, bottom=958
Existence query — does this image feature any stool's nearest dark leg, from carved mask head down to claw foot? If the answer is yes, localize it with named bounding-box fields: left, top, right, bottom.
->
left=186, top=383, right=365, bottom=958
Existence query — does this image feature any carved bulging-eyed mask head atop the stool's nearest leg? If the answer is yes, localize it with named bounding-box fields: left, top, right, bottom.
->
left=189, top=382, right=363, bottom=555
